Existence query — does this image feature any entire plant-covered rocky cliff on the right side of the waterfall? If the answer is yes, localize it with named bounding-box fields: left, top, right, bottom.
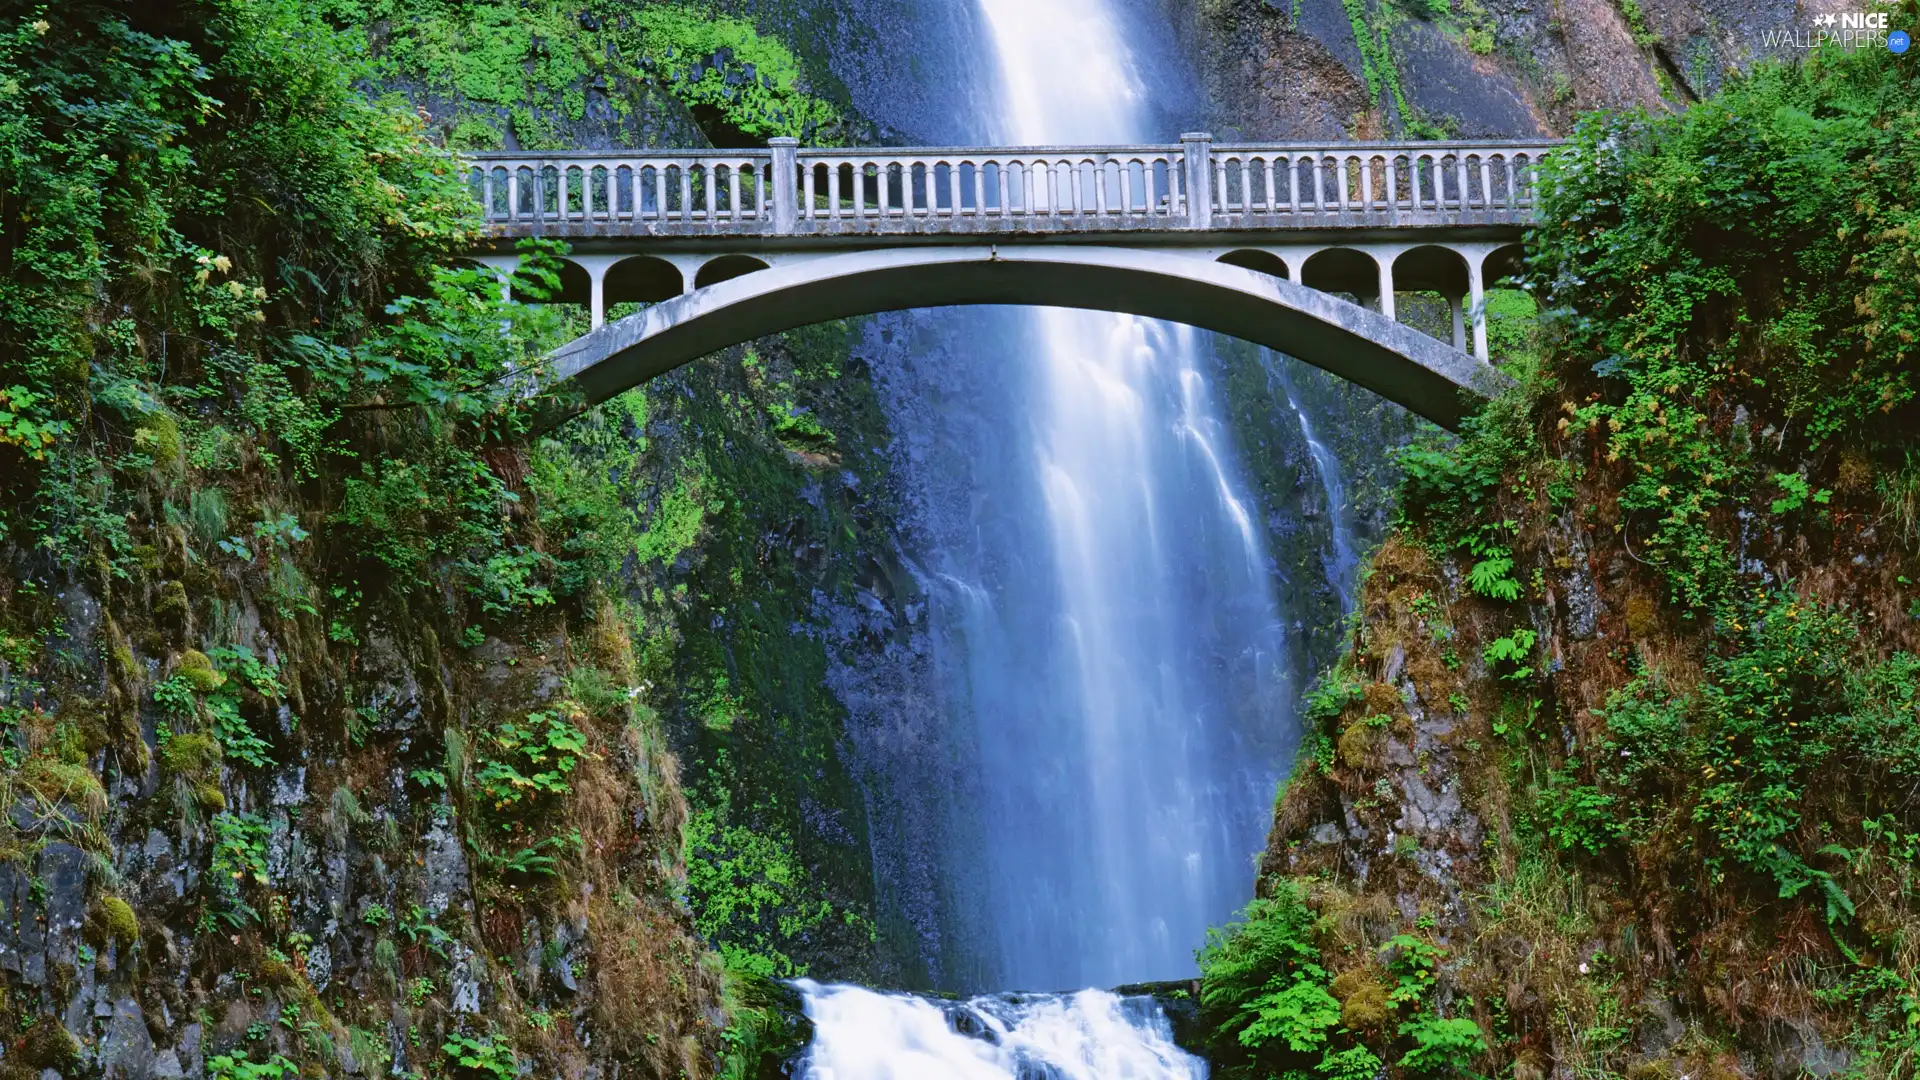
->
left=1202, top=25, right=1920, bottom=1078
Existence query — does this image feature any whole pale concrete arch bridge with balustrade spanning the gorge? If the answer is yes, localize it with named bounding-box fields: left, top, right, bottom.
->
left=470, top=135, right=1553, bottom=427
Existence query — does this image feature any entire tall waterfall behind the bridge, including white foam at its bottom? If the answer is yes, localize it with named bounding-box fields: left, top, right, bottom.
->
left=803, top=0, right=1298, bottom=1045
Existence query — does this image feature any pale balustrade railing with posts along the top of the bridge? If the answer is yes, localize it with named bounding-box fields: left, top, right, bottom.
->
left=470, top=135, right=1553, bottom=246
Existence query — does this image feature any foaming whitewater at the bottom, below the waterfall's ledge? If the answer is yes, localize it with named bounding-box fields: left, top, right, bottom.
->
left=795, top=980, right=1206, bottom=1080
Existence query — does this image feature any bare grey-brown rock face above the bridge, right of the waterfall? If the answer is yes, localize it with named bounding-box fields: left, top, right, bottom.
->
left=1160, top=0, right=1812, bottom=140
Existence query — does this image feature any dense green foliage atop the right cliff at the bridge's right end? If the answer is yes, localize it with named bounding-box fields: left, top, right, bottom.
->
left=1530, top=52, right=1920, bottom=609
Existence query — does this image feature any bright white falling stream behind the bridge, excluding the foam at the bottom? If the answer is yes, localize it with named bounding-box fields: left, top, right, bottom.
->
left=977, top=0, right=1286, bottom=986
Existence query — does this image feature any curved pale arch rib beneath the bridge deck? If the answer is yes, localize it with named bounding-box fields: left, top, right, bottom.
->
left=545, top=244, right=1507, bottom=427
